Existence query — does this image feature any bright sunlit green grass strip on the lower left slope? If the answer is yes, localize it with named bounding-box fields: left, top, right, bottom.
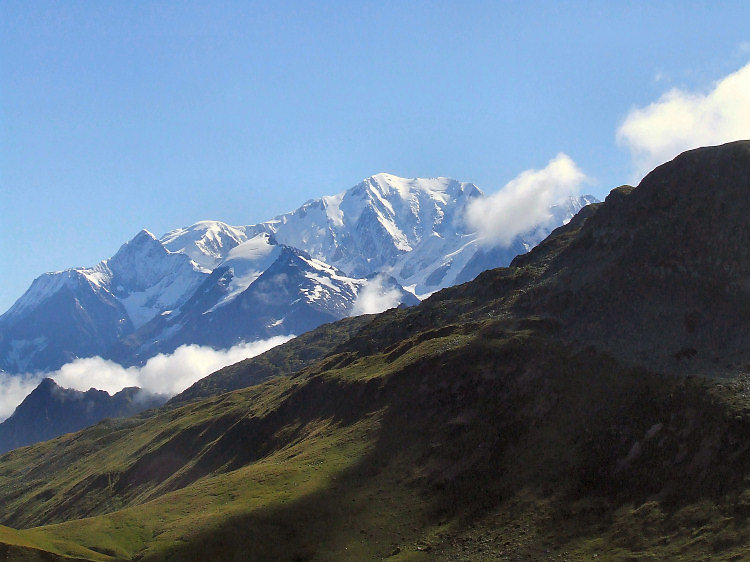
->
left=27, top=414, right=382, bottom=558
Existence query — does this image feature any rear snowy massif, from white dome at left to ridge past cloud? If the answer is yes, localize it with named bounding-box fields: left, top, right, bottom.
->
left=161, top=174, right=596, bottom=298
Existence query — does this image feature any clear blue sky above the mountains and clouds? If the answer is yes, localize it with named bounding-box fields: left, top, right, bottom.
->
left=0, top=0, right=750, bottom=312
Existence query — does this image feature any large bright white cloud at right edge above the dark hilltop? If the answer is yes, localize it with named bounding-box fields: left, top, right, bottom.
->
left=617, top=59, right=750, bottom=181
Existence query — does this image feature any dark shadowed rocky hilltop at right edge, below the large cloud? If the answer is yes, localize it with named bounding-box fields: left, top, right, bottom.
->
left=511, top=141, right=750, bottom=375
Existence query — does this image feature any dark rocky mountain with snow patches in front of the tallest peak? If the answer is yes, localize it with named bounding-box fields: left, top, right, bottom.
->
left=110, top=241, right=419, bottom=362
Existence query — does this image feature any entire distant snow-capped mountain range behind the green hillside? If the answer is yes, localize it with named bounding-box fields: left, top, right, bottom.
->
left=0, top=174, right=593, bottom=372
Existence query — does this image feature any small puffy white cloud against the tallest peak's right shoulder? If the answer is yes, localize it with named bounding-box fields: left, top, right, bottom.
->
left=466, top=153, right=587, bottom=246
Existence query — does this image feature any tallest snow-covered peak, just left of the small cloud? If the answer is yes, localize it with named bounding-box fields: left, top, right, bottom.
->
left=258, top=173, right=490, bottom=277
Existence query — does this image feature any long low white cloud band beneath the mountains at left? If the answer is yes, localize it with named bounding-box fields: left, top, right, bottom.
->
left=0, top=336, right=293, bottom=421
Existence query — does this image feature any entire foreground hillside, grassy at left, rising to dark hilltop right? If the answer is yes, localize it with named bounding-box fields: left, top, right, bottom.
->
left=0, top=141, right=750, bottom=560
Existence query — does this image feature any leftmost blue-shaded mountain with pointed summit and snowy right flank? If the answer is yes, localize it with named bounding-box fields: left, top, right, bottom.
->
left=0, top=230, right=210, bottom=372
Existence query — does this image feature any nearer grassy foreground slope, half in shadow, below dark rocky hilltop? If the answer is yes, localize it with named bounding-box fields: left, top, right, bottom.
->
left=2, top=321, right=750, bottom=560
